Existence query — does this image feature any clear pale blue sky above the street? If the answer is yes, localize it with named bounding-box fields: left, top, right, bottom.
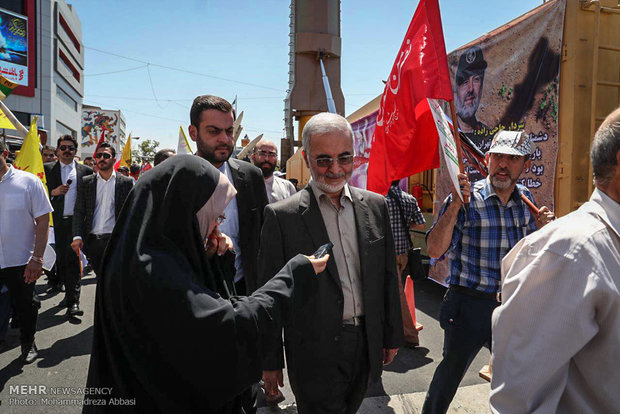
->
left=68, top=0, right=542, bottom=152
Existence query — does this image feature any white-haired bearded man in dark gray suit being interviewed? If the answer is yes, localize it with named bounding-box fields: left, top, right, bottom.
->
left=259, top=113, right=403, bottom=414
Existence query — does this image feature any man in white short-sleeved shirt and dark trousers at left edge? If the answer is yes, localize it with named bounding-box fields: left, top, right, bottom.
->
left=0, top=140, right=52, bottom=364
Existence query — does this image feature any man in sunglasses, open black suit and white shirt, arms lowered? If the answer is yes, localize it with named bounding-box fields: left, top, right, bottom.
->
left=71, top=142, right=133, bottom=276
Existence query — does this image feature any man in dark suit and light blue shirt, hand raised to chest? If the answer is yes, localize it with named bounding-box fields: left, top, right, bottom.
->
left=44, top=135, right=93, bottom=316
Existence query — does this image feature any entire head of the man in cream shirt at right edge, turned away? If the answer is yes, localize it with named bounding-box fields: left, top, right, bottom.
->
left=590, top=108, right=620, bottom=203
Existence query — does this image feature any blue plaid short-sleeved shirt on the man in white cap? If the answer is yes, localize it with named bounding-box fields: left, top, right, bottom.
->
left=429, top=178, right=537, bottom=293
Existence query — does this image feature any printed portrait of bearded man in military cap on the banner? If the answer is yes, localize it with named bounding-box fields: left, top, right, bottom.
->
left=455, top=46, right=488, bottom=137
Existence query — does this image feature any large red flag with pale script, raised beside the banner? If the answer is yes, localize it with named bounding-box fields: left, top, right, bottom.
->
left=367, top=0, right=452, bottom=194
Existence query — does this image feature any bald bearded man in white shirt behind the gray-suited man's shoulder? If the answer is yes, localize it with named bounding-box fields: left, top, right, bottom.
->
left=251, top=139, right=297, bottom=204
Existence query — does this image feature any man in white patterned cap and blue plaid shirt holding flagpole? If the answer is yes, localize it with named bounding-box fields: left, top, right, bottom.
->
left=422, top=131, right=554, bottom=413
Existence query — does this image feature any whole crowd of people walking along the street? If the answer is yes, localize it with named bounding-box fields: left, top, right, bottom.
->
left=0, top=94, right=620, bottom=414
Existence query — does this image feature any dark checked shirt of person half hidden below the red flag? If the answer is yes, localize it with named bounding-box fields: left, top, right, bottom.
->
left=385, top=186, right=425, bottom=255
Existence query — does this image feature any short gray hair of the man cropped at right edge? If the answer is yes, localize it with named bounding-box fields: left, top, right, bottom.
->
left=590, top=118, right=620, bottom=185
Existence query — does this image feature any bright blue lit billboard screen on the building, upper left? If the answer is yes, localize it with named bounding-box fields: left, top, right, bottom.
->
left=0, top=9, right=28, bottom=86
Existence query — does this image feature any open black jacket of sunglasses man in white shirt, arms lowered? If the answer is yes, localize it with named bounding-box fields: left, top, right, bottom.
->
left=73, top=174, right=134, bottom=239
